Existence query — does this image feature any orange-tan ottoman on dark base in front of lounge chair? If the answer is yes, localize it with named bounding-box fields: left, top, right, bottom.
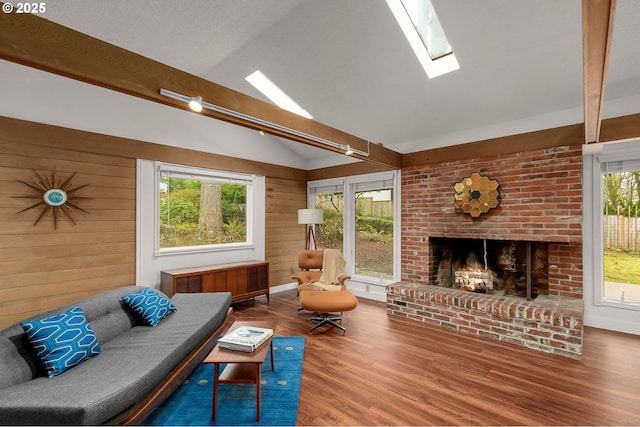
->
left=300, top=290, right=358, bottom=335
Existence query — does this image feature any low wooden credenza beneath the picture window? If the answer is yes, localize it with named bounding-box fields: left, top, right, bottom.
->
left=160, top=261, right=270, bottom=303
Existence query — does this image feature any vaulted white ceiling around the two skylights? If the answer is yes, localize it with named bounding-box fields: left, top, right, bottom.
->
left=0, top=0, right=640, bottom=168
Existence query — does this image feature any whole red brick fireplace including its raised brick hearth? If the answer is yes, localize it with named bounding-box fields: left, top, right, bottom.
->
left=387, top=145, right=582, bottom=358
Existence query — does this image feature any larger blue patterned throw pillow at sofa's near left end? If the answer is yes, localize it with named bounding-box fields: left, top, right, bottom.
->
left=20, top=306, right=102, bottom=378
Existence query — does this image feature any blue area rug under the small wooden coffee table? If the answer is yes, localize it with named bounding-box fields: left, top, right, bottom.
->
left=144, top=337, right=305, bottom=426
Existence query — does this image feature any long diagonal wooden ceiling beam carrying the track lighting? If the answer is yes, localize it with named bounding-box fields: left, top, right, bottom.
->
left=0, top=8, right=402, bottom=169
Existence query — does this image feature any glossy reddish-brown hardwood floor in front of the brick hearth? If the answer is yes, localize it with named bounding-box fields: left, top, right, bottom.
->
left=234, top=290, right=640, bottom=426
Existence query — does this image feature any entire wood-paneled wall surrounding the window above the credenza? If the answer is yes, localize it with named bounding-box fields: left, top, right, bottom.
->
left=0, top=117, right=306, bottom=329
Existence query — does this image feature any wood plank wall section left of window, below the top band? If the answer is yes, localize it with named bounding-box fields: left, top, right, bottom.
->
left=0, top=132, right=136, bottom=329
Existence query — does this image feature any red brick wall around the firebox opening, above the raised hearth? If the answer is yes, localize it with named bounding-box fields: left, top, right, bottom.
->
left=401, top=145, right=582, bottom=298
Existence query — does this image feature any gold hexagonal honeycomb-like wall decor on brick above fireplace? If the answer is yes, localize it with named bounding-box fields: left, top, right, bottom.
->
left=453, top=173, right=500, bottom=218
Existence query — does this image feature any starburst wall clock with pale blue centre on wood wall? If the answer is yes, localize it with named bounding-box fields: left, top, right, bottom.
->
left=15, top=170, right=89, bottom=229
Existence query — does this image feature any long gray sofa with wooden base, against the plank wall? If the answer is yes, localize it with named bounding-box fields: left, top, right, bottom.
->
left=0, top=286, right=231, bottom=425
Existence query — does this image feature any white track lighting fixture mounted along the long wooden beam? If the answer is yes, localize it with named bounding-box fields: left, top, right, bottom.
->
left=160, top=88, right=369, bottom=157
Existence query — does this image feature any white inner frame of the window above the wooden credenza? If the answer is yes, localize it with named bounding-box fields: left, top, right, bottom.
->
left=154, top=162, right=256, bottom=256
